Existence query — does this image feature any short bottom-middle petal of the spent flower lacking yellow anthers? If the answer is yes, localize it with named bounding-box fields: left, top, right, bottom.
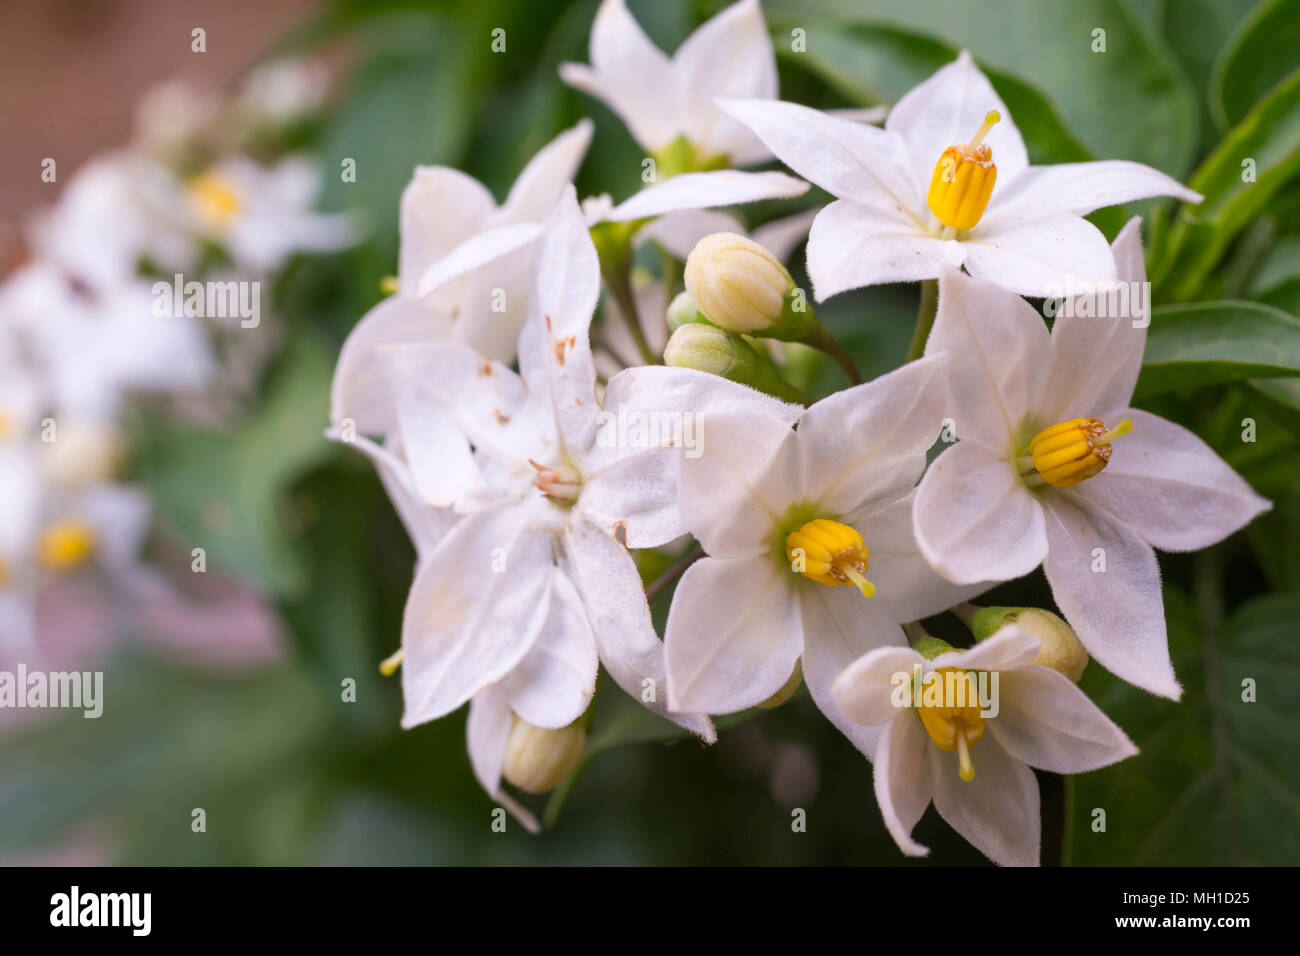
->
left=501, top=571, right=599, bottom=728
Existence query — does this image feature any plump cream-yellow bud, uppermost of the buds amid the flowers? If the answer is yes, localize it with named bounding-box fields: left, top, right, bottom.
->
left=685, top=233, right=794, bottom=333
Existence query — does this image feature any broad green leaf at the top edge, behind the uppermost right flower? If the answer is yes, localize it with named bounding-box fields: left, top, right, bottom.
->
left=763, top=0, right=1197, bottom=177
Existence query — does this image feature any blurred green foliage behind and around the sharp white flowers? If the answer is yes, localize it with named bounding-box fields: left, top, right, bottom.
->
left=0, top=0, right=1300, bottom=865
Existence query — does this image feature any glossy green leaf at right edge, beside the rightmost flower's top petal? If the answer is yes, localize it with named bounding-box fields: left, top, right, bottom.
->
left=1136, top=302, right=1300, bottom=398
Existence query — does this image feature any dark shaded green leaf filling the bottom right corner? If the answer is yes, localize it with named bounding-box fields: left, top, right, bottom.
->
left=1071, top=587, right=1300, bottom=866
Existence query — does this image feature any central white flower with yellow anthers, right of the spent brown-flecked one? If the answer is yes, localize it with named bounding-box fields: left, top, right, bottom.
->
left=660, top=358, right=979, bottom=754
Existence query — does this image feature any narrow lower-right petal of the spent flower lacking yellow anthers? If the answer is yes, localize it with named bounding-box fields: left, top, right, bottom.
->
left=564, top=522, right=718, bottom=744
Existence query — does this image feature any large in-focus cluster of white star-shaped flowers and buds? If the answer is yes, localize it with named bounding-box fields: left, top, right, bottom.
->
left=332, top=0, right=1268, bottom=865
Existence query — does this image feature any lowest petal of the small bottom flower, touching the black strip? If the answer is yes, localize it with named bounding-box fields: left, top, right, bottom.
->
left=928, top=734, right=1043, bottom=866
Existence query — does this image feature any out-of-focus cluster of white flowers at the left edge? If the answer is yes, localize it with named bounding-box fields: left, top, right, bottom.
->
left=0, top=62, right=355, bottom=661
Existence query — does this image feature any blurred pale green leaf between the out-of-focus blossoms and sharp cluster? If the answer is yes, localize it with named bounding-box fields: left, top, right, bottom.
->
left=139, top=336, right=334, bottom=596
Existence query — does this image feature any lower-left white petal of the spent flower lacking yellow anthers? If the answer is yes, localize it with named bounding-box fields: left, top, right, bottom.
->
left=402, top=506, right=555, bottom=728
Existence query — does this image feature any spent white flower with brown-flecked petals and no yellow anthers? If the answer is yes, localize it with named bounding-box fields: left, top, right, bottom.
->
left=366, top=187, right=806, bottom=743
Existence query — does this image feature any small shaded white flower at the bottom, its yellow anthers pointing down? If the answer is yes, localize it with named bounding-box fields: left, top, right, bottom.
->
left=833, top=624, right=1138, bottom=866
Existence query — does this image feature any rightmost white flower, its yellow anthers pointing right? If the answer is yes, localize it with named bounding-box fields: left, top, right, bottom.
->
left=915, top=219, right=1269, bottom=698
